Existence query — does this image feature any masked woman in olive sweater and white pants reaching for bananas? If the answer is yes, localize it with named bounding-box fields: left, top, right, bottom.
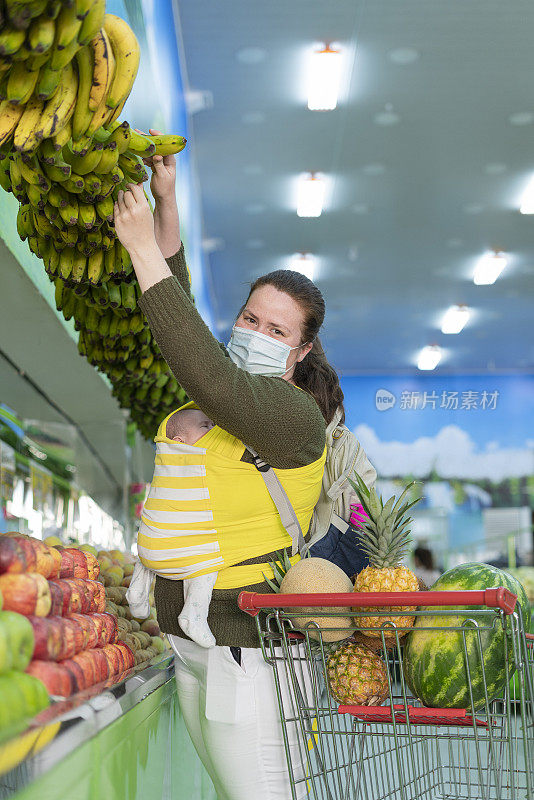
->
left=115, top=141, right=343, bottom=800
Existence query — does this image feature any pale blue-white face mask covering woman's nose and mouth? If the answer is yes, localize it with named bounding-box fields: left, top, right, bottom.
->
left=226, top=326, right=303, bottom=378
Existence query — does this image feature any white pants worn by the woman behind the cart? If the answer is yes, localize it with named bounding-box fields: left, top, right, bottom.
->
left=168, top=635, right=309, bottom=800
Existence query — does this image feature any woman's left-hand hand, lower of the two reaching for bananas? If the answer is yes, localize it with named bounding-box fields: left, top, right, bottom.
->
left=114, top=183, right=156, bottom=255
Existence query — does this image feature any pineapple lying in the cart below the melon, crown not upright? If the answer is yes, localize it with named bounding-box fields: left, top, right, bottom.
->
left=326, top=642, right=389, bottom=706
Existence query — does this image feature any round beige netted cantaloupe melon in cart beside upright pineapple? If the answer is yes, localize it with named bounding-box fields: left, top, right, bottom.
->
left=280, top=558, right=354, bottom=642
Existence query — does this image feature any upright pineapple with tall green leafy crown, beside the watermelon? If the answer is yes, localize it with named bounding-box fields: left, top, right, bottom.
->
left=350, top=475, right=419, bottom=642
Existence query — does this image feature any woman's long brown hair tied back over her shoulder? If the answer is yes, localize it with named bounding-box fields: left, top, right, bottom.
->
left=245, top=269, right=345, bottom=425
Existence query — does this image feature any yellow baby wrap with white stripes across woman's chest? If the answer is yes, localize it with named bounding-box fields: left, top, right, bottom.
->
left=137, top=403, right=325, bottom=589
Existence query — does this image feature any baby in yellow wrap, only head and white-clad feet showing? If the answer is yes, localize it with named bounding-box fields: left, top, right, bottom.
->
left=126, top=408, right=218, bottom=647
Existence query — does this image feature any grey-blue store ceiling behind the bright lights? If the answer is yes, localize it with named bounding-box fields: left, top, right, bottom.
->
left=178, top=0, right=534, bottom=374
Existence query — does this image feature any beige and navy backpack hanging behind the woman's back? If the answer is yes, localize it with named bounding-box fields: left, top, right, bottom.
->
left=303, top=409, right=376, bottom=577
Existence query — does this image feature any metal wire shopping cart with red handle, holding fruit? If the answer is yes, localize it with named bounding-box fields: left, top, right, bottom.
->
left=239, top=588, right=534, bottom=800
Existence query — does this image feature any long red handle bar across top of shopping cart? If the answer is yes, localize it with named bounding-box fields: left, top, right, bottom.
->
left=237, top=586, right=517, bottom=617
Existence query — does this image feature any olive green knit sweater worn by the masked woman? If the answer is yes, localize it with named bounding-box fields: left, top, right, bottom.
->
left=139, top=245, right=325, bottom=647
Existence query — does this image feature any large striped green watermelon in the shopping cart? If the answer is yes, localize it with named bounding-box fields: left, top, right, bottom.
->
left=404, top=564, right=530, bottom=710
